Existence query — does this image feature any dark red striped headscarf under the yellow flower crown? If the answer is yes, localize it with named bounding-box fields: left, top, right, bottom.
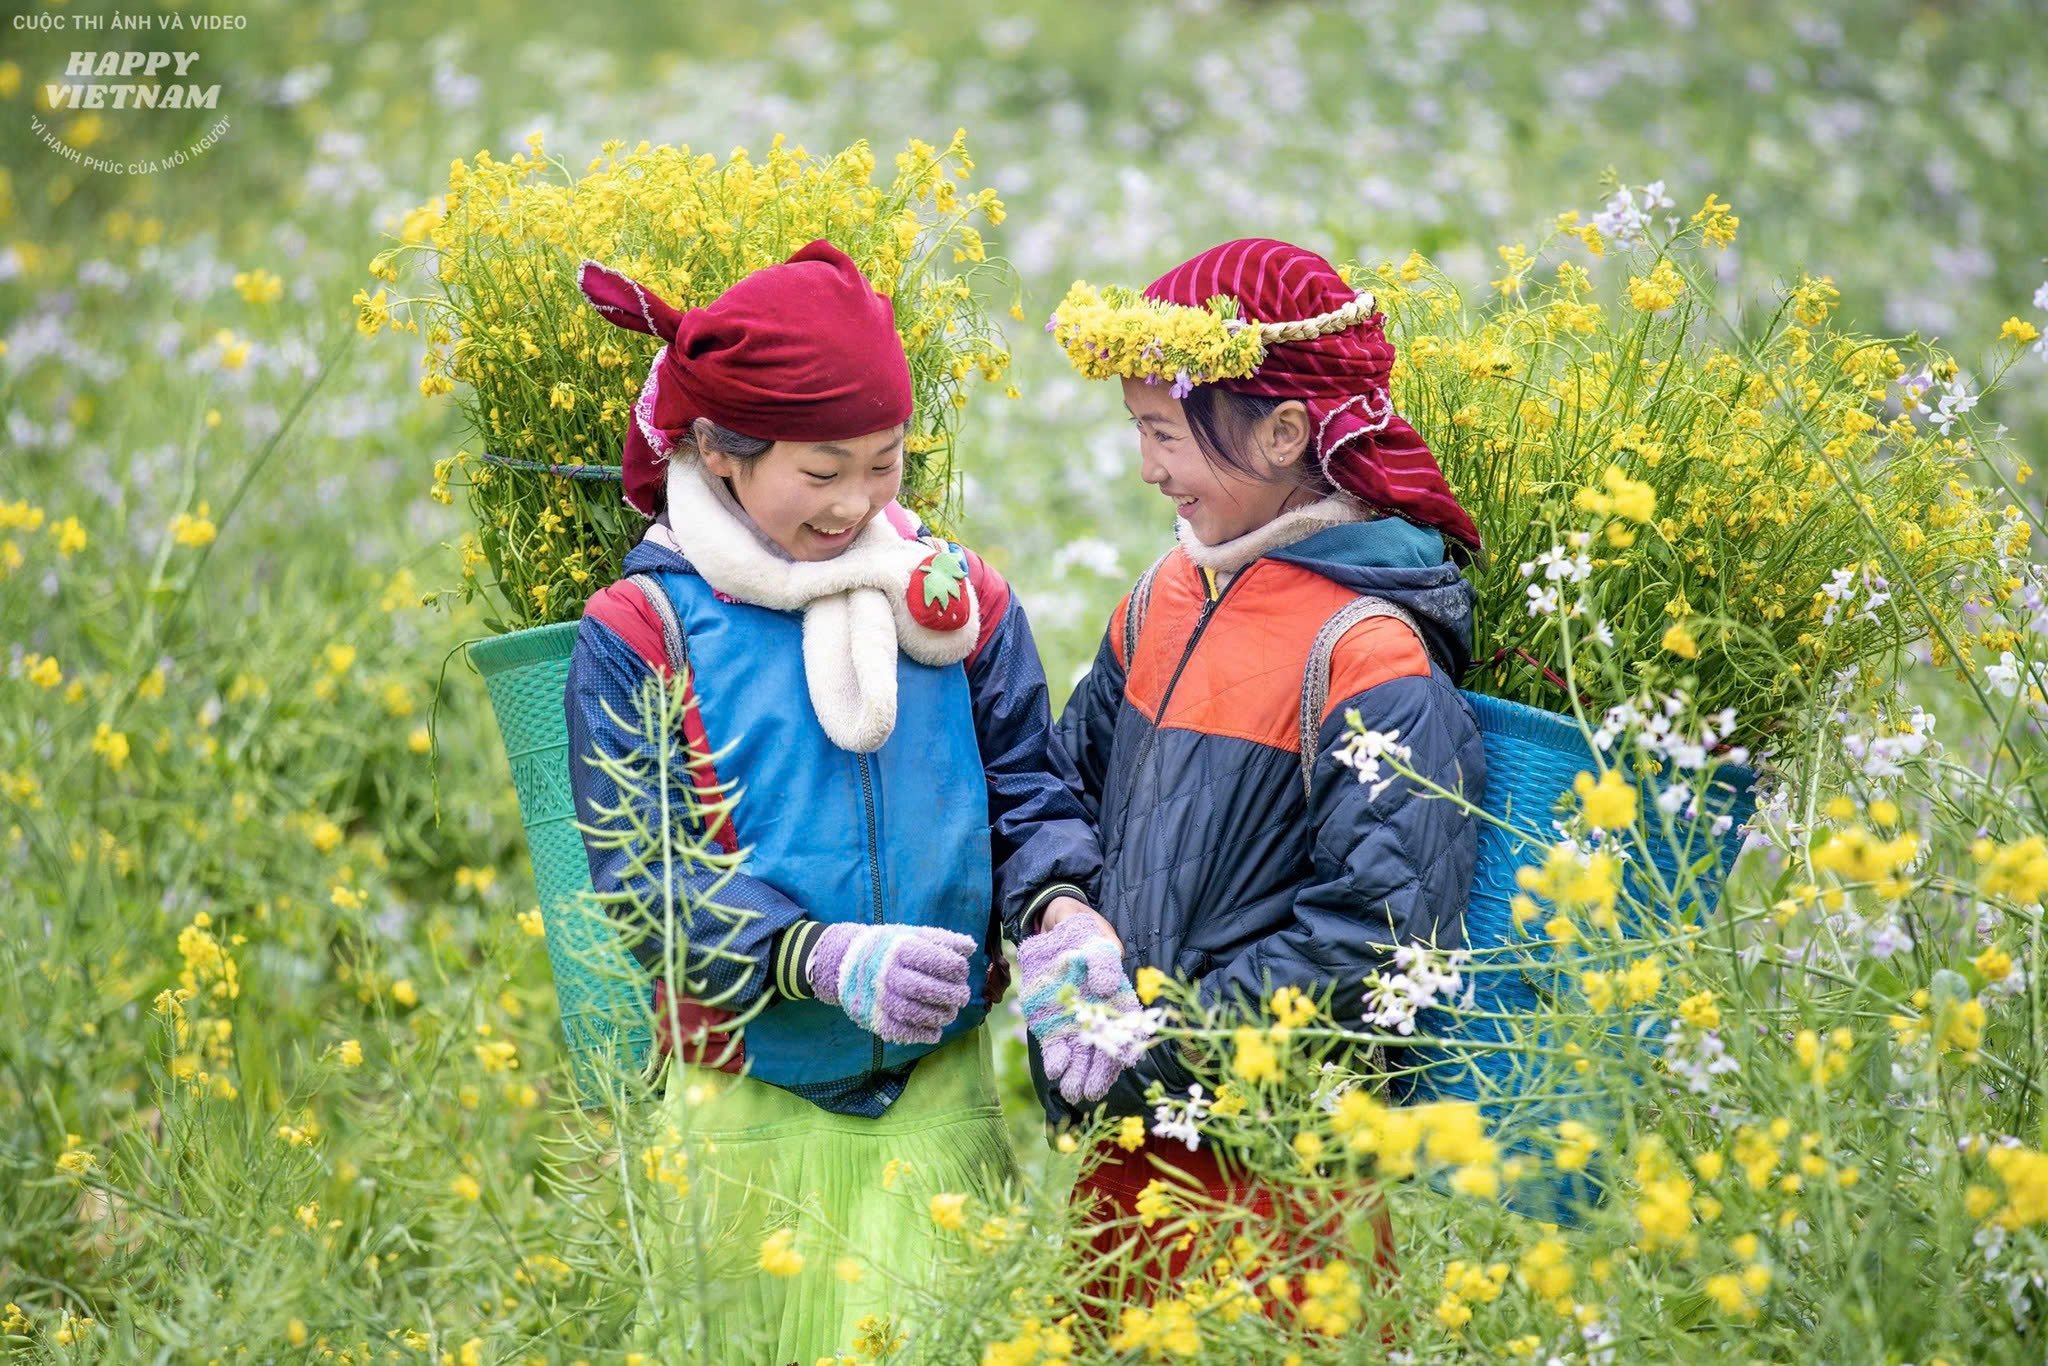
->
left=1145, top=238, right=1479, bottom=549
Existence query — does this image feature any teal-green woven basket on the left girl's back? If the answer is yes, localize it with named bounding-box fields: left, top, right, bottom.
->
left=469, top=621, right=649, bottom=1098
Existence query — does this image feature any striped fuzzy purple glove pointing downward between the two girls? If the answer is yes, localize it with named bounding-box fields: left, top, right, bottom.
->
left=1018, top=915, right=1151, bottom=1104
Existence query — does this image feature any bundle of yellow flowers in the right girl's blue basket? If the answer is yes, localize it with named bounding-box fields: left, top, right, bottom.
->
left=1346, top=197, right=2025, bottom=731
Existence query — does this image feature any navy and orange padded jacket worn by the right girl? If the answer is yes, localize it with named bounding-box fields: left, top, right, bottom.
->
left=1030, top=518, right=1487, bottom=1122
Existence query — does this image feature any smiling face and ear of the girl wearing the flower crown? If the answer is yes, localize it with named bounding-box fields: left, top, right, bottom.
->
left=1124, top=379, right=1315, bottom=545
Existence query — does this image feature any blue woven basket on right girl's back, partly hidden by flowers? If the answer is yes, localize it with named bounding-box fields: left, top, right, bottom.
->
left=1395, top=692, right=1755, bottom=1223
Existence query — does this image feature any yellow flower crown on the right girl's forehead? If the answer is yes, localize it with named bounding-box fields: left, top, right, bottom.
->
left=1044, top=281, right=1374, bottom=397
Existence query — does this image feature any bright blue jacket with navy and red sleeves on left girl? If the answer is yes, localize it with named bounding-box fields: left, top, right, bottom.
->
left=563, top=508, right=1100, bottom=1118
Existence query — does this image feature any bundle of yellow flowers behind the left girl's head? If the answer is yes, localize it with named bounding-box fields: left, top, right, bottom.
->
left=366, top=131, right=1014, bottom=631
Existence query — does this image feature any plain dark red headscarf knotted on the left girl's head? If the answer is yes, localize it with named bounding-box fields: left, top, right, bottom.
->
left=575, top=242, right=911, bottom=516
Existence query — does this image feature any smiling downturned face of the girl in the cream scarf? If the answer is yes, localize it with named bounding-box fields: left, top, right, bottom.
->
left=700, top=426, right=905, bottom=559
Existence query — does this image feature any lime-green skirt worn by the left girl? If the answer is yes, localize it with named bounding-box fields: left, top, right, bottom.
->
left=635, top=1026, right=1016, bottom=1366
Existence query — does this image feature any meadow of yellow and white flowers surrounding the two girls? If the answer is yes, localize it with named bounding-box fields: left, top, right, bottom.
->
left=0, top=0, right=2048, bottom=1366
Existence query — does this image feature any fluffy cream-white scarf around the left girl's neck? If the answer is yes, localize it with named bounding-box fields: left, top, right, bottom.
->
left=647, top=455, right=981, bottom=754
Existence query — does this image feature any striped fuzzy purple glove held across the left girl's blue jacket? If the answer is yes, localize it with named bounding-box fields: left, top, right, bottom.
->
left=807, top=924, right=975, bottom=1044
